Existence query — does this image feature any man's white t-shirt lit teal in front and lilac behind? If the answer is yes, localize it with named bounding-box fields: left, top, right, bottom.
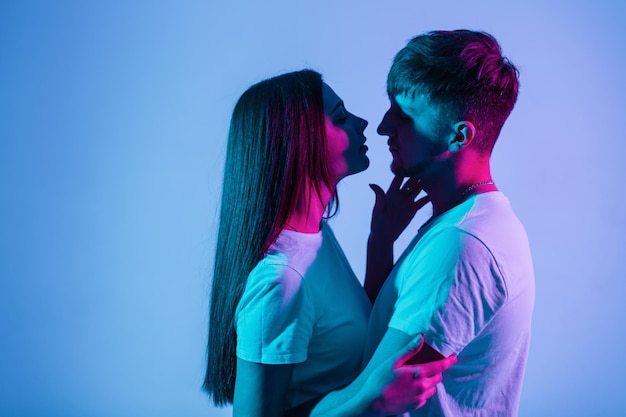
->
left=366, top=192, right=534, bottom=417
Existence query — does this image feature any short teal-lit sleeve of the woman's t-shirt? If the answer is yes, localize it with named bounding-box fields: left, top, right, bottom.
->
left=235, top=261, right=315, bottom=365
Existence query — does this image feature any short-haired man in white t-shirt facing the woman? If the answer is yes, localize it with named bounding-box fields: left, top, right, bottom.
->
left=290, top=30, right=534, bottom=417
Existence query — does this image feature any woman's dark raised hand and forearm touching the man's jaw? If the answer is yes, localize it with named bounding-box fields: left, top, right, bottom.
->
left=363, top=176, right=430, bottom=303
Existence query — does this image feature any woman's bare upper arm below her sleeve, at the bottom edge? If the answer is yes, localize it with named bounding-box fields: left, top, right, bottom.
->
left=233, top=358, right=293, bottom=417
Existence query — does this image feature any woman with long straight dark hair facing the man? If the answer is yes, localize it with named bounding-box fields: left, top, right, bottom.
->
left=204, top=70, right=454, bottom=416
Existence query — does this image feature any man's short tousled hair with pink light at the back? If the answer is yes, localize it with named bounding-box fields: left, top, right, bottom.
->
left=387, top=30, right=519, bottom=153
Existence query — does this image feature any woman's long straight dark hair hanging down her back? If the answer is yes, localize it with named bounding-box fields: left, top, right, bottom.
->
left=203, top=70, right=335, bottom=406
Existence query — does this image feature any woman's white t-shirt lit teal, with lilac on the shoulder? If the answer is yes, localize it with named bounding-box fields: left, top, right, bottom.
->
left=235, top=222, right=371, bottom=408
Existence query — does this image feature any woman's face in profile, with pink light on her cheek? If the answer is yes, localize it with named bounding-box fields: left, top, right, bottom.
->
left=322, top=83, right=370, bottom=180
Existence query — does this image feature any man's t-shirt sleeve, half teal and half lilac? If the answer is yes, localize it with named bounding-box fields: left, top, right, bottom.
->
left=389, top=228, right=506, bottom=356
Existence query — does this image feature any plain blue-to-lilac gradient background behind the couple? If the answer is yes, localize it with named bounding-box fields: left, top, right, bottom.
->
left=0, top=0, right=626, bottom=417
